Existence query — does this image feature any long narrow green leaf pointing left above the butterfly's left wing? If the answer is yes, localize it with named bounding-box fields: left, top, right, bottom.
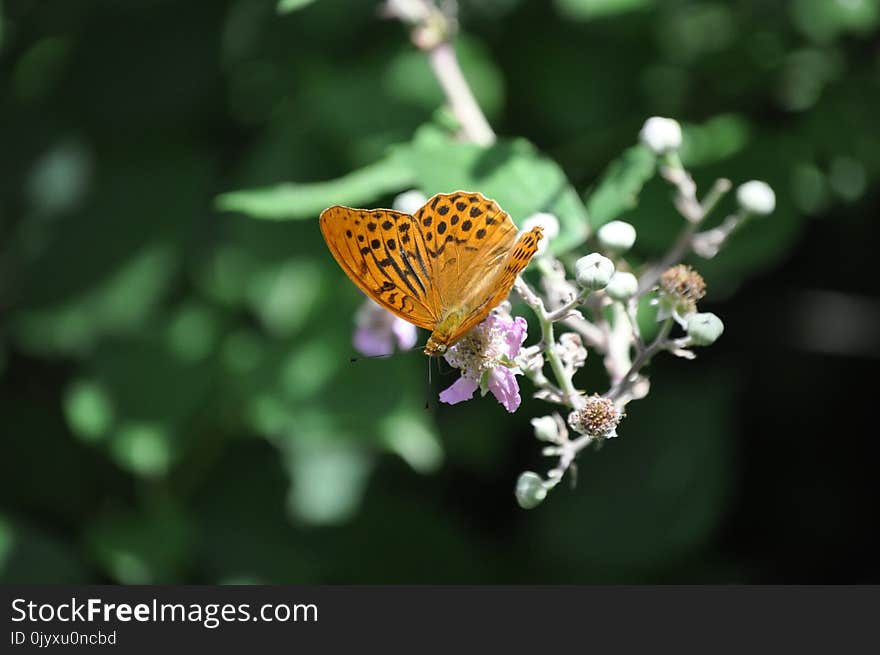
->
left=216, top=150, right=413, bottom=220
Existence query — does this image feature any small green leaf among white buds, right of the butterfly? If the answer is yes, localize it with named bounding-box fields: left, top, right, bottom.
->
left=587, top=145, right=656, bottom=228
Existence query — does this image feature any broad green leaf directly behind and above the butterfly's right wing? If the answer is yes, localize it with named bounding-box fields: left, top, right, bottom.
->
left=409, top=125, right=589, bottom=252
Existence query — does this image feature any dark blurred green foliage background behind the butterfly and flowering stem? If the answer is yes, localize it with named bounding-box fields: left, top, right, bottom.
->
left=0, top=0, right=880, bottom=583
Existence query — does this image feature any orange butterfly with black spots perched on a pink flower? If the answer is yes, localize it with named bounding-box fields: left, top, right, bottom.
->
left=320, top=191, right=542, bottom=355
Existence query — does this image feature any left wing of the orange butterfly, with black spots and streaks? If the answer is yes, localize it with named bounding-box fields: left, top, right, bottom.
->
left=319, top=205, right=438, bottom=330
